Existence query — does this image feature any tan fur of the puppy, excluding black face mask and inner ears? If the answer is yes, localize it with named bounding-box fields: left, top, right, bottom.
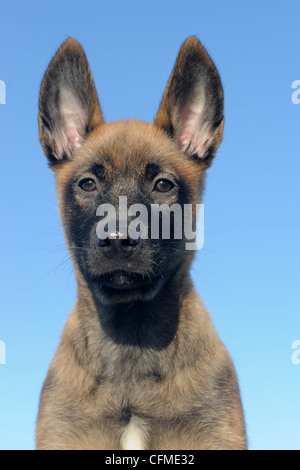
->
left=36, top=35, right=246, bottom=450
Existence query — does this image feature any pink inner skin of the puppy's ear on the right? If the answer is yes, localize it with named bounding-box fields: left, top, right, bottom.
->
left=175, top=99, right=213, bottom=158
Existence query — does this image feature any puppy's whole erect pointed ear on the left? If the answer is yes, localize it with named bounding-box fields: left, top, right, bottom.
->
left=39, top=38, right=104, bottom=165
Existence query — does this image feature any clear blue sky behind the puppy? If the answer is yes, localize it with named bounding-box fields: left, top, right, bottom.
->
left=0, top=0, right=300, bottom=450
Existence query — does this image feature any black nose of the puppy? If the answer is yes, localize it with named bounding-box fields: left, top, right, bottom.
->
left=98, top=232, right=141, bottom=258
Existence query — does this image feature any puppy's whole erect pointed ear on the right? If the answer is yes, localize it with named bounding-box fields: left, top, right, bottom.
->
left=154, top=37, right=224, bottom=165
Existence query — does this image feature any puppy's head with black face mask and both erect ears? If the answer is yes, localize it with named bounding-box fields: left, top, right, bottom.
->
left=39, top=37, right=224, bottom=303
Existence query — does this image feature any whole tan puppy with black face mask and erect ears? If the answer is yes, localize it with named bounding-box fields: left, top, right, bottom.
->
left=37, top=37, right=246, bottom=450
